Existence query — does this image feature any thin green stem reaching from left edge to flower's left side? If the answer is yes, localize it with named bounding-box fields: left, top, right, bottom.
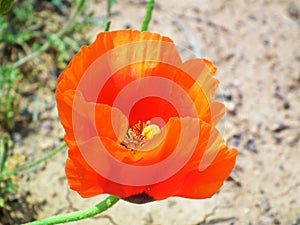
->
left=0, top=143, right=66, bottom=179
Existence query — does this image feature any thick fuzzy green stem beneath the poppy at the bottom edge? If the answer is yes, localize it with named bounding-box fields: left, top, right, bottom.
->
left=23, top=195, right=120, bottom=225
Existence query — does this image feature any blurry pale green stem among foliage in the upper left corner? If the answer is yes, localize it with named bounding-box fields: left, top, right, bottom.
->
left=12, top=0, right=85, bottom=68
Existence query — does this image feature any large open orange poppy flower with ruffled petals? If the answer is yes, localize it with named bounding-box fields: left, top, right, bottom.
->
left=56, top=30, right=237, bottom=203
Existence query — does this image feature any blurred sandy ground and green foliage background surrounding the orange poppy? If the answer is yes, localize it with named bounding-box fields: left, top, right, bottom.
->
left=0, top=0, right=300, bottom=225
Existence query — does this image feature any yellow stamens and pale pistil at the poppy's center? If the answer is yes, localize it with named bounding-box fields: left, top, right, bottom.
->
left=121, top=121, right=160, bottom=150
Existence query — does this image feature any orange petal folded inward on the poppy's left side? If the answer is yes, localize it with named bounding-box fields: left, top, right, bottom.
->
left=56, top=90, right=128, bottom=145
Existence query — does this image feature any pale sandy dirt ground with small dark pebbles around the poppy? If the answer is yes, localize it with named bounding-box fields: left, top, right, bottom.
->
left=6, top=0, right=300, bottom=225
